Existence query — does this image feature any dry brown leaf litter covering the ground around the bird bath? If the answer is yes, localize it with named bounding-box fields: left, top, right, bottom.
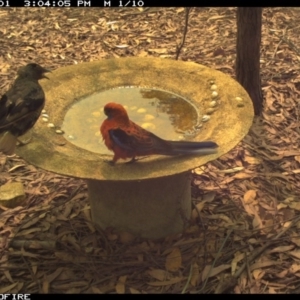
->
left=0, top=7, right=300, bottom=294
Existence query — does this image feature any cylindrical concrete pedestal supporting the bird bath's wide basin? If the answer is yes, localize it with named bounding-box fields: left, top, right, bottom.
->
left=87, top=172, right=191, bottom=239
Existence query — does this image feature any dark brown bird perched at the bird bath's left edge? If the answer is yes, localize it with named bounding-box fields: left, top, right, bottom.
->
left=0, top=63, right=50, bottom=155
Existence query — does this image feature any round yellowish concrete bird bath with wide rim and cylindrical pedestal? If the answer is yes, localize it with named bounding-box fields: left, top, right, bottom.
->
left=17, top=58, right=253, bottom=238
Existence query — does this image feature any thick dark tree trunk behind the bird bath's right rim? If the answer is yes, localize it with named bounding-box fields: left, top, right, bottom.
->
left=236, top=7, right=263, bottom=115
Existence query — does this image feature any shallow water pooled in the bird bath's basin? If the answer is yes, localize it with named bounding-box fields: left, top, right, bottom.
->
left=62, top=87, right=200, bottom=154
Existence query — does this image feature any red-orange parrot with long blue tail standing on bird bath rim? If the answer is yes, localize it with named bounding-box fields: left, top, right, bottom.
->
left=100, top=102, right=218, bottom=164
